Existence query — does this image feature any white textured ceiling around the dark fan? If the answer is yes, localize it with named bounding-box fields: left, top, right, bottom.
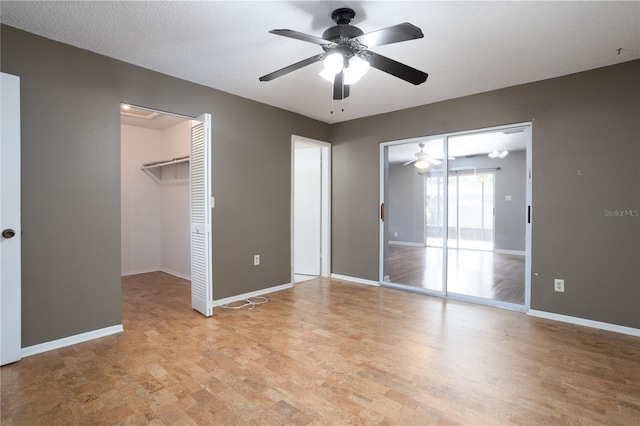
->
left=0, top=1, right=640, bottom=123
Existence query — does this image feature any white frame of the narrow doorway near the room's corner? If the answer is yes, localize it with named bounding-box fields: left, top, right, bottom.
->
left=291, top=135, right=331, bottom=285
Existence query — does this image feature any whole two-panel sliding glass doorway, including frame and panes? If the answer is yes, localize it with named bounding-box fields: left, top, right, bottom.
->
left=380, top=123, right=531, bottom=311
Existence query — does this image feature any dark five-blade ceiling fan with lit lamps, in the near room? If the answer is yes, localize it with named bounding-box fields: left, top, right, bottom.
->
left=260, top=8, right=429, bottom=100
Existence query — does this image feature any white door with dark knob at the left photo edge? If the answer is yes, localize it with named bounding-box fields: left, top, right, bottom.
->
left=0, top=73, right=21, bottom=365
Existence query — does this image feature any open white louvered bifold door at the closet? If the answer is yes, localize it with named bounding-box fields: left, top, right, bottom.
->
left=190, top=114, right=213, bottom=316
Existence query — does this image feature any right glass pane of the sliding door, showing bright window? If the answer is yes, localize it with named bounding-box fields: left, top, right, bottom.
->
left=447, top=131, right=526, bottom=304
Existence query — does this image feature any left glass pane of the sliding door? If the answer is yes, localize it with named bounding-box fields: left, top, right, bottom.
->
left=383, top=138, right=445, bottom=291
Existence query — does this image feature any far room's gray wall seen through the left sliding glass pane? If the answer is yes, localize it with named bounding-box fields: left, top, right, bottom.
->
left=385, top=164, right=424, bottom=244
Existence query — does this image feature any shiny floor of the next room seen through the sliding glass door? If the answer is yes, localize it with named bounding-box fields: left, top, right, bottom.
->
left=387, top=245, right=525, bottom=305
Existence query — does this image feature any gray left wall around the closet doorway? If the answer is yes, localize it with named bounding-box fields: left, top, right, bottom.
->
left=1, top=26, right=330, bottom=347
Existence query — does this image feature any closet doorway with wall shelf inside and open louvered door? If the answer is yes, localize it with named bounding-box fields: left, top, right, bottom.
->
left=120, top=104, right=213, bottom=316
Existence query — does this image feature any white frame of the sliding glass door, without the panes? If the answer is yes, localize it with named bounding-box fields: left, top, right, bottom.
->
left=378, top=121, right=533, bottom=312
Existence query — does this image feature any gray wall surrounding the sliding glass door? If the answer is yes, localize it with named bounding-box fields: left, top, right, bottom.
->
left=331, top=61, right=640, bottom=327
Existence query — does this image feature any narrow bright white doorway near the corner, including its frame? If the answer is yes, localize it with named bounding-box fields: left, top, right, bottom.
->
left=291, top=135, right=331, bottom=283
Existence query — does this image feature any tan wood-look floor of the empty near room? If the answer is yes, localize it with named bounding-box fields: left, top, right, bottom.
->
left=0, top=272, right=640, bottom=426
